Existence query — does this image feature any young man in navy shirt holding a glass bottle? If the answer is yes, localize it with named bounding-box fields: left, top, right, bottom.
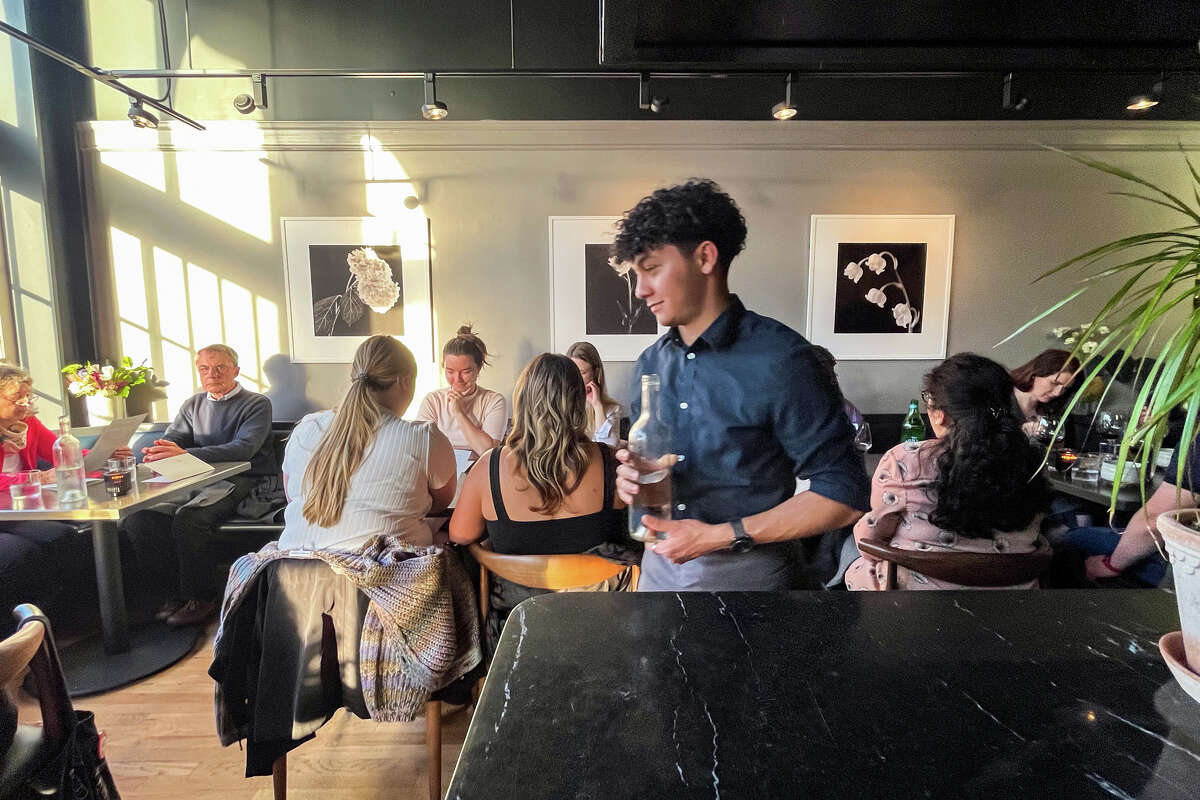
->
left=613, top=180, right=869, bottom=591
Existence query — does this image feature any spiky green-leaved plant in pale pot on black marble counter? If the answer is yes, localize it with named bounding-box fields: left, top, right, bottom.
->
left=1006, top=145, right=1200, bottom=673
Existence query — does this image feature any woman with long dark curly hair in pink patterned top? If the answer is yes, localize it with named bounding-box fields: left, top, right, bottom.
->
left=846, top=353, right=1049, bottom=589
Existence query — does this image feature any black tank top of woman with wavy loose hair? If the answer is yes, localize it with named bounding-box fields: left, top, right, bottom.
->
left=486, top=444, right=625, bottom=555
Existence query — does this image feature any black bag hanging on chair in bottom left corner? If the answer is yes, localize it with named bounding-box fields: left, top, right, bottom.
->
left=18, top=710, right=121, bottom=800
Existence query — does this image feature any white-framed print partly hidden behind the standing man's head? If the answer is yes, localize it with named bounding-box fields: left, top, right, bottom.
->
left=550, top=216, right=667, bottom=361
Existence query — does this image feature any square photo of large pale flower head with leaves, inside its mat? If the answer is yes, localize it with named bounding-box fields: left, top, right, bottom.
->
left=308, top=245, right=404, bottom=336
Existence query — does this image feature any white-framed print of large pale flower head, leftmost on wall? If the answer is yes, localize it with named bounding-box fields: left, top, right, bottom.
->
left=280, top=211, right=436, bottom=363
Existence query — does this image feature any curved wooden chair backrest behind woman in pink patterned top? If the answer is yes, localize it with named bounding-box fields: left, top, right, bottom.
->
left=858, top=539, right=1054, bottom=587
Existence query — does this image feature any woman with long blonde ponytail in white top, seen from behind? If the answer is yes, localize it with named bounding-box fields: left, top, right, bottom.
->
left=280, top=336, right=457, bottom=551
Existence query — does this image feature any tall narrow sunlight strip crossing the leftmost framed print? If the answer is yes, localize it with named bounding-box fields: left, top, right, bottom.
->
left=360, top=134, right=442, bottom=415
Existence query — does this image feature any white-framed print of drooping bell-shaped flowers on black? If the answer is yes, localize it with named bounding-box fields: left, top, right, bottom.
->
left=805, top=213, right=954, bottom=361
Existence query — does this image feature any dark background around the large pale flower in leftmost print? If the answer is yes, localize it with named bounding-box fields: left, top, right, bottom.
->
left=308, top=245, right=404, bottom=336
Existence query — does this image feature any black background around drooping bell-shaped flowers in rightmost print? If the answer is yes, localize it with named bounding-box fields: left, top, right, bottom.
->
left=833, top=242, right=929, bottom=333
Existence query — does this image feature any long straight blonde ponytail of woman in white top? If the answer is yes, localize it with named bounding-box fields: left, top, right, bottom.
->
left=302, top=336, right=416, bottom=528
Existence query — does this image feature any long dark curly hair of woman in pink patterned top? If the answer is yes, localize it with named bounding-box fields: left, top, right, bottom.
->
left=924, top=353, right=1050, bottom=539
